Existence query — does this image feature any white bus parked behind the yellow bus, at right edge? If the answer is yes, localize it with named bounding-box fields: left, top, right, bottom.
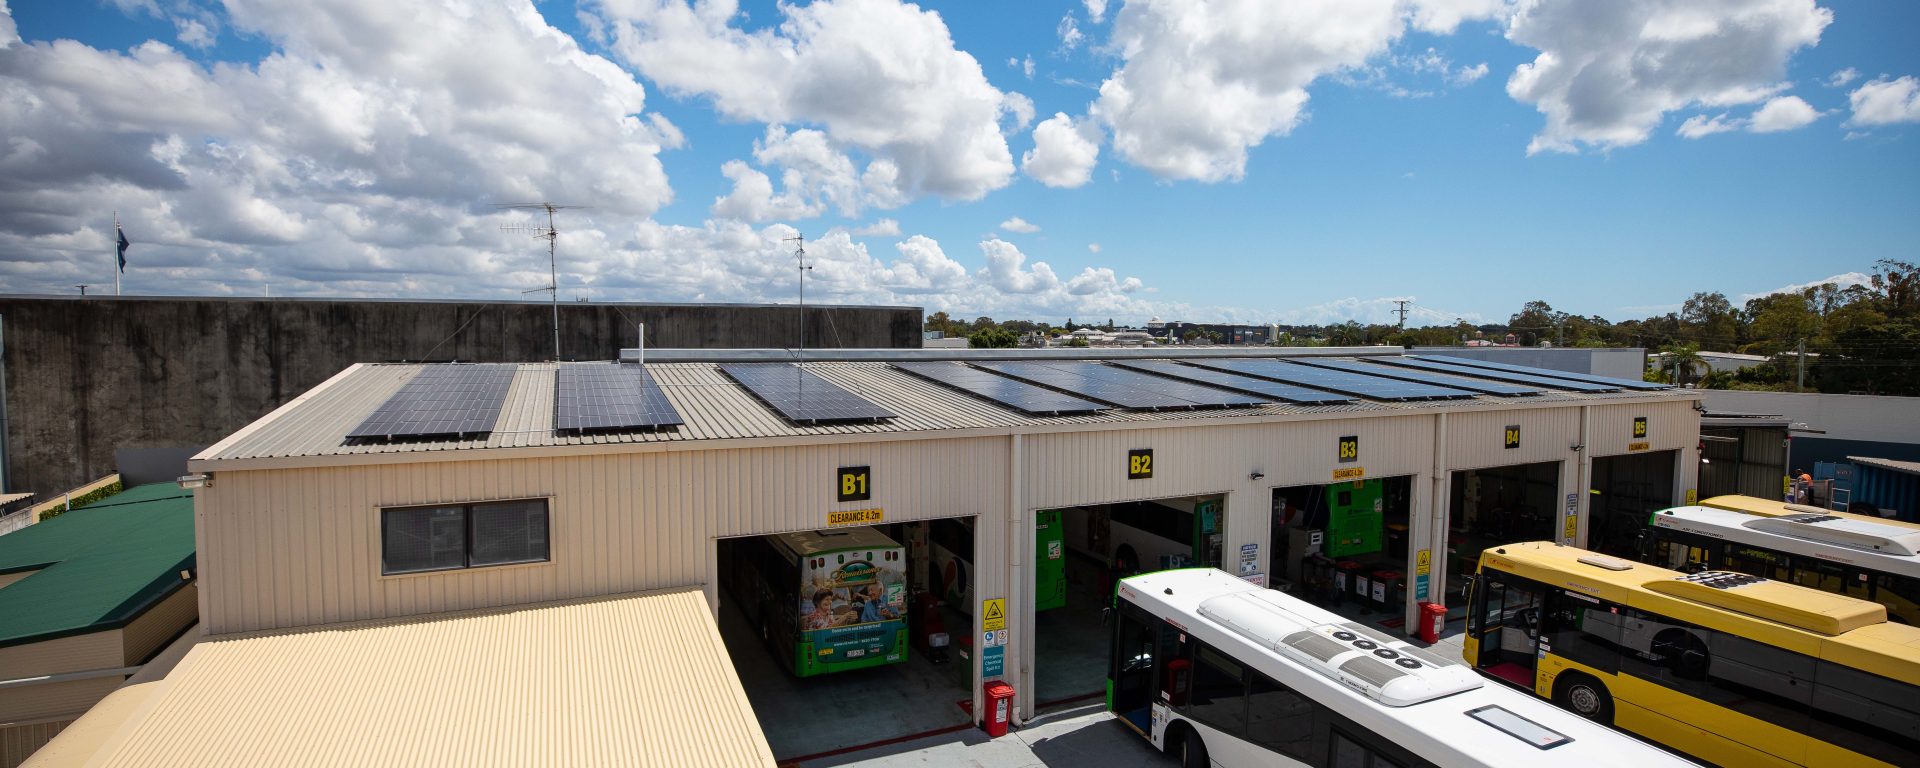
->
left=1645, top=497, right=1920, bottom=624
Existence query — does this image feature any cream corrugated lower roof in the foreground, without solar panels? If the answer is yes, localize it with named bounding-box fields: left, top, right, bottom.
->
left=88, top=588, right=774, bottom=768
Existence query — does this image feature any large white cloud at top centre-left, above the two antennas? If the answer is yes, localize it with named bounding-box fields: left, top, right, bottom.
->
left=589, top=0, right=1031, bottom=200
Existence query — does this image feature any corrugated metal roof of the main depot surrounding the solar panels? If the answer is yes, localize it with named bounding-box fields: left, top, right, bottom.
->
left=196, top=361, right=1697, bottom=461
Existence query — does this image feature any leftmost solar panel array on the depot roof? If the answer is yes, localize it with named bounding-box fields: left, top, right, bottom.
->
left=348, top=363, right=518, bottom=440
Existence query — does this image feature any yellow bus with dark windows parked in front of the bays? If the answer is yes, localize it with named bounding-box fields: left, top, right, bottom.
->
left=1465, top=541, right=1920, bottom=768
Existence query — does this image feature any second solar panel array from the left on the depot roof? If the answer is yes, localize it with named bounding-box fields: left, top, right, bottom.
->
left=553, top=363, right=685, bottom=434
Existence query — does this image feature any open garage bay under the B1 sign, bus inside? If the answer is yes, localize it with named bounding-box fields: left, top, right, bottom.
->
left=714, top=518, right=973, bottom=760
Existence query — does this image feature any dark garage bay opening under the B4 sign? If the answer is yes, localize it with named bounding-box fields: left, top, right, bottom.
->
left=1446, top=461, right=1565, bottom=609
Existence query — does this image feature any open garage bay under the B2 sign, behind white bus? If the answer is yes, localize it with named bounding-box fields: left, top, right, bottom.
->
left=1033, top=493, right=1227, bottom=707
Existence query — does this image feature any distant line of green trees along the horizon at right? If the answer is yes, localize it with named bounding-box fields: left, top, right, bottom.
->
left=925, top=259, right=1920, bottom=396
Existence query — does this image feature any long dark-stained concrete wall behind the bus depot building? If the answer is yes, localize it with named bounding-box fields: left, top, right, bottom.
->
left=0, top=296, right=922, bottom=493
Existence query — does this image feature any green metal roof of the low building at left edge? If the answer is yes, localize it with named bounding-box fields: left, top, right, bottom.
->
left=0, top=482, right=194, bottom=647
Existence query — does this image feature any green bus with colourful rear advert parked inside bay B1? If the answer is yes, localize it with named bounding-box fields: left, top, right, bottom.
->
left=720, top=528, right=906, bottom=678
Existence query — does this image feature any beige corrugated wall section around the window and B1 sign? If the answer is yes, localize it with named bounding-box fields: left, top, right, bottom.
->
left=194, top=438, right=1008, bottom=634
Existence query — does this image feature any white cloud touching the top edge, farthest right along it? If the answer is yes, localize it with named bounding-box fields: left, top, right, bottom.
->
left=1507, top=0, right=1834, bottom=154
